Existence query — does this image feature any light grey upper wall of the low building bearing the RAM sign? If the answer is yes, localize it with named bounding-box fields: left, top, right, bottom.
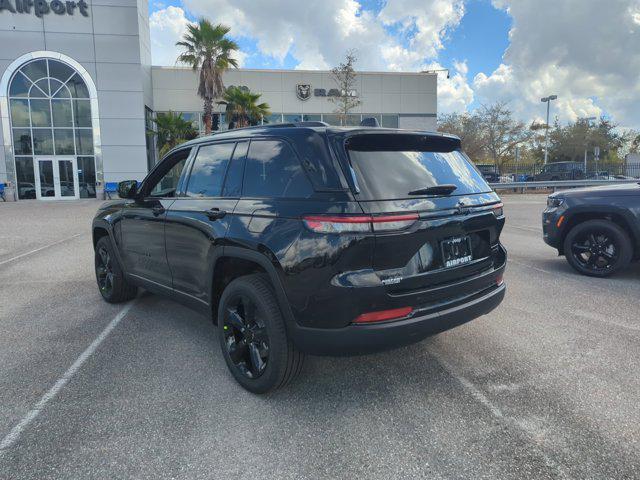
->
left=152, top=67, right=437, bottom=130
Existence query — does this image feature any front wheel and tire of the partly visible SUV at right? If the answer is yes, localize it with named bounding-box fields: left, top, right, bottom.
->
left=564, top=220, right=633, bottom=278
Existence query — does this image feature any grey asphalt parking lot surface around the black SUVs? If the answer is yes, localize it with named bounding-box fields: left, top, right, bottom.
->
left=0, top=195, right=640, bottom=479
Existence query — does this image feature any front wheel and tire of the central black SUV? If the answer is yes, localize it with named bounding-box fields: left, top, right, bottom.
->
left=94, top=236, right=138, bottom=303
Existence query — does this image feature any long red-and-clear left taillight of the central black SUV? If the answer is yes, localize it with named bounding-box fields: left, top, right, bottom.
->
left=302, top=213, right=418, bottom=233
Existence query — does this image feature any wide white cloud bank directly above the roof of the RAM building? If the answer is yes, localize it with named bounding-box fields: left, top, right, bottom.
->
left=184, top=0, right=463, bottom=71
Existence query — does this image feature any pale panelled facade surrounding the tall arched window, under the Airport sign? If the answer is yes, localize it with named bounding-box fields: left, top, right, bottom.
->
left=0, top=0, right=153, bottom=199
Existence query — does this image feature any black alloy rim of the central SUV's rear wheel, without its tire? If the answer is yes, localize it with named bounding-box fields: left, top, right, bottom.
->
left=222, top=295, right=269, bottom=379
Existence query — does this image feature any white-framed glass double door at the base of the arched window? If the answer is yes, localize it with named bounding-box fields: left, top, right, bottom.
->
left=34, top=157, right=80, bottom=200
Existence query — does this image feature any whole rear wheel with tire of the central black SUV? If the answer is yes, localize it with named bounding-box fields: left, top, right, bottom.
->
left=218, top=274, right=305, bottom=394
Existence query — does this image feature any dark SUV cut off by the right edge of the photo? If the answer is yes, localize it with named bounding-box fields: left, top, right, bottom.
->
left=542, top=183, right=640, bottom=277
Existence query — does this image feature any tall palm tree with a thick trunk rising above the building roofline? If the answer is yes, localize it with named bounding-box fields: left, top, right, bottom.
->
left=176, top=18, right=239, bottom=134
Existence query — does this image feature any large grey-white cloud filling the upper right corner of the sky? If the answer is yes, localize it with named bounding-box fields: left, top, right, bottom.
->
left=473, top=0, right=640, bottom=127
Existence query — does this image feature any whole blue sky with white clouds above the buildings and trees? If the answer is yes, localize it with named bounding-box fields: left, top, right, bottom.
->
left=149, top=0, right=640, bottom=129
